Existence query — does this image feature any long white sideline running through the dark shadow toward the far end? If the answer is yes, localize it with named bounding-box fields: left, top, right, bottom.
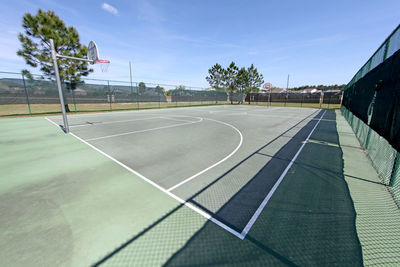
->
left=241, top=110, right=326, bottom=237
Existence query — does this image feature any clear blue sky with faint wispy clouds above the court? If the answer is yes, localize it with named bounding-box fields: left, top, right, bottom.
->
left=0, top=0, right=400, bottom=87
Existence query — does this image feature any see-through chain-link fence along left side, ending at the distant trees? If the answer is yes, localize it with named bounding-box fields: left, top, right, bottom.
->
left=0, top=72, right=229, bottom=116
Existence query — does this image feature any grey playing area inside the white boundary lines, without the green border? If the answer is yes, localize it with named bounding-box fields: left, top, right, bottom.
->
left=50, top=105, right=323, bottom=238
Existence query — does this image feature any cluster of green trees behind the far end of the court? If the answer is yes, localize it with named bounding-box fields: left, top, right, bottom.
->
left=206, top=61, right=264, bottom=93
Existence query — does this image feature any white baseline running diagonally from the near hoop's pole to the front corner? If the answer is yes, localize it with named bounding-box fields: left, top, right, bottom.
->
left=46, top=118, right=244, bottom=240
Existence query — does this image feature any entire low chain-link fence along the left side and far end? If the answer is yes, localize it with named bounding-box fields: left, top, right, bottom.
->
left=0, top=72, right=341, bottom=116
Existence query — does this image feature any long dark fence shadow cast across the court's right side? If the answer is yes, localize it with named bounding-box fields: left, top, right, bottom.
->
left=95, top=110, right=362, bottom=266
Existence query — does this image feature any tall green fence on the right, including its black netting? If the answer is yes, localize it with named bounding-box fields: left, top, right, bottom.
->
left=342, top=25, right=400, bottom=204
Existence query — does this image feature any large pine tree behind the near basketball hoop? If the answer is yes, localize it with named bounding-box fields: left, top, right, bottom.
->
left=17, top=9, right=93, bottom=83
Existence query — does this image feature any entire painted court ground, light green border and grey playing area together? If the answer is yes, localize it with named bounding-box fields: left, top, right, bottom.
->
left=0, top=105, right=400, bottom=266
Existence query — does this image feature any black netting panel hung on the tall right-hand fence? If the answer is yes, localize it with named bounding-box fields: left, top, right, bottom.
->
left=343, top=51, right=400, bottom=150
